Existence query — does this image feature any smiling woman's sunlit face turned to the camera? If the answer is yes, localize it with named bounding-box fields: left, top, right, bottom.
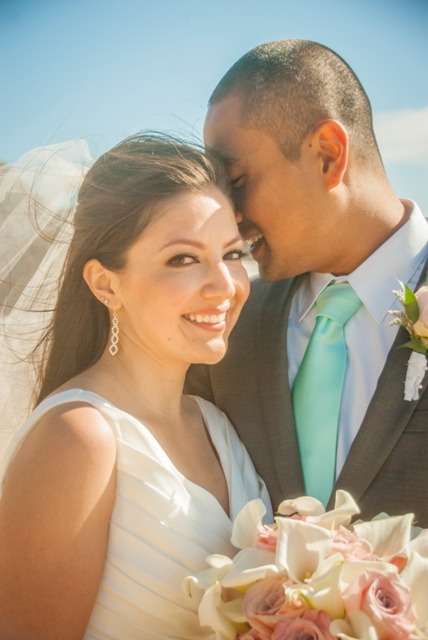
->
left=113, top=187, right=249, bottom=366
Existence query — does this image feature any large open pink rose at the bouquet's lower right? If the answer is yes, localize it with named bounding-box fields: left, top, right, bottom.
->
left=342, top=570, right=416, bottom=640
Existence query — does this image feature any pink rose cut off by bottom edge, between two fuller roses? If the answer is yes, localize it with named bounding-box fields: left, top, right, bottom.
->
left=271, top=609, right=337, bottom=640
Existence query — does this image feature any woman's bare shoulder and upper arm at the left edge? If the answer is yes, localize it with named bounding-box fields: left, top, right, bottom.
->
left=0, top=402, right=116, bottom=638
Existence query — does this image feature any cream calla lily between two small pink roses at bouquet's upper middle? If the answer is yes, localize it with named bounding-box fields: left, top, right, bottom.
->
left=275, top=517, right=331, bottom=582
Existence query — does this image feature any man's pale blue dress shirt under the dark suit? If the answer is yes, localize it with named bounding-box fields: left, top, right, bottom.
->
left=287, top=201, right=428, bottom=475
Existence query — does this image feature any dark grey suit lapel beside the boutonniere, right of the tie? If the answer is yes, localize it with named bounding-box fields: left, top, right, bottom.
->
left=333, top=262, right=428, bottom=502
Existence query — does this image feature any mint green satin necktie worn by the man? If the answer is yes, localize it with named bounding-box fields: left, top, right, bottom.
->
left=292, top=282, right=361, bottom=505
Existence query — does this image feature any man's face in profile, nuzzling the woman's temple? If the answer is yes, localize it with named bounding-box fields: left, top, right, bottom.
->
left=204, top=97, right=332, bottom=280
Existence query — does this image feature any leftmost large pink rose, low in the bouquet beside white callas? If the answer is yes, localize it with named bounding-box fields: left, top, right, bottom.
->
left=243, top=572, right=288, bottom=638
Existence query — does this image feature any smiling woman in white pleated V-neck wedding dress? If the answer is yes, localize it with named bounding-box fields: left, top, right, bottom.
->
left=0, top=134, right=272, bottom=640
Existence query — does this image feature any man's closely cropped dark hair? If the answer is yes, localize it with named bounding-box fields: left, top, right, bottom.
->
left=209, top=40, right=380, bottom=163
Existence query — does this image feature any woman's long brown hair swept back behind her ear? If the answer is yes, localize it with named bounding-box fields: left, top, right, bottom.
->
left=35, top=133, right=229, bottom=404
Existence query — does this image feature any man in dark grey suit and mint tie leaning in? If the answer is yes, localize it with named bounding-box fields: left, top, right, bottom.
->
left=187, top=40, right=428, bottom=527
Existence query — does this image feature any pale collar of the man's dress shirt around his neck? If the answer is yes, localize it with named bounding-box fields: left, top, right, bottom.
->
left=298, top=200, right=428, bottom=324
